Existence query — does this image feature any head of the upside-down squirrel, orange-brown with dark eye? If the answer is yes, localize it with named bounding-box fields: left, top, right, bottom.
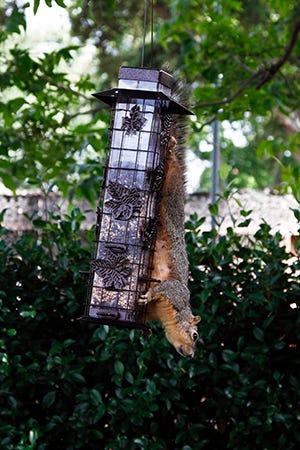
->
left=165, top=315, right=201, bottom=357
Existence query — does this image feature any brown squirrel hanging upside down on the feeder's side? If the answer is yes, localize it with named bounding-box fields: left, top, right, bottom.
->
left=141, top=136, right=200, bottom=356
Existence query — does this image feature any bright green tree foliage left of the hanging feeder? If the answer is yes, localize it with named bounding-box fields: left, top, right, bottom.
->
left=0, top=2, right=107, bottom=201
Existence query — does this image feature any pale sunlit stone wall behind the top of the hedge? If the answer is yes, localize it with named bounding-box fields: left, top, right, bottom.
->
left=0, top=189, right=299, bottom=236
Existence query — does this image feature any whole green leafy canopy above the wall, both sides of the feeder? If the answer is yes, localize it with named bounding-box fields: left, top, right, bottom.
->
left=0, top=0, right=300, bottom=201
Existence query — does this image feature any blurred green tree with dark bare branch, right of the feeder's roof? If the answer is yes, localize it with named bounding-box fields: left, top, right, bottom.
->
left=71, top=0, right=300, bottom=195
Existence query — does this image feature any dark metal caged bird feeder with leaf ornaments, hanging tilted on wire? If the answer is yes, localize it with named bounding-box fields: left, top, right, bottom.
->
left=82, top=67, right=190, bottom=330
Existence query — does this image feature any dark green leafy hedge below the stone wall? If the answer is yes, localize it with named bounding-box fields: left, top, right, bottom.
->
left=0, top=206, right=300, bottom=450
